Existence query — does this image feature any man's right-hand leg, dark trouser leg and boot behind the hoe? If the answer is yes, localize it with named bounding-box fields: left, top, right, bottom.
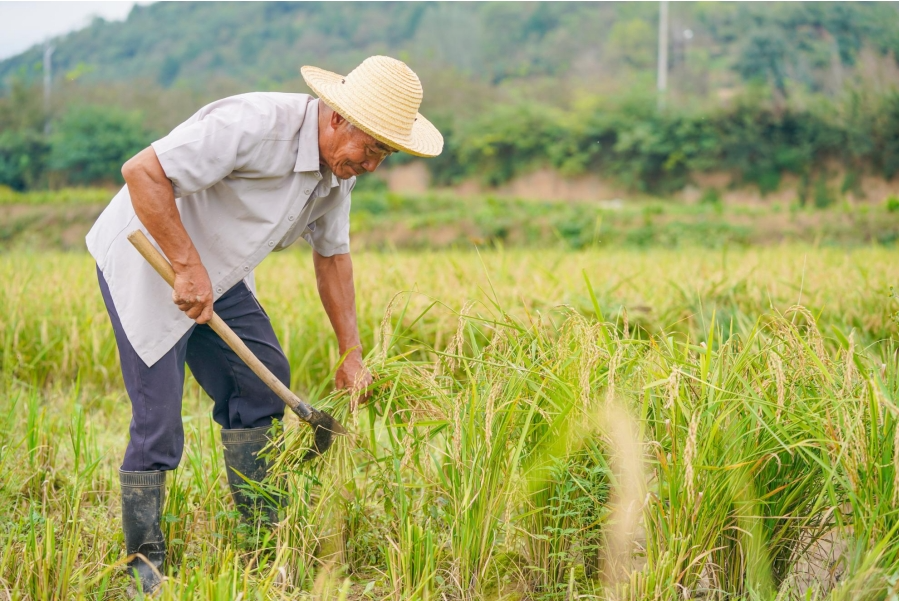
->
left=187, top=282, right=290, bottom=523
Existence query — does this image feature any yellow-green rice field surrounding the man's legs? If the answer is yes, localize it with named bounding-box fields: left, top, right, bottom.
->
left=0, top=245, right=899, bottom=601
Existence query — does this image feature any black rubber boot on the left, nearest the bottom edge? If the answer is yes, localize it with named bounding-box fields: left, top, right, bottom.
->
left=119, top=471, right=165, bottom=593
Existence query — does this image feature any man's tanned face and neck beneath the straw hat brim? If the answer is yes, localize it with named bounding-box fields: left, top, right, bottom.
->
left=321, top=112, right=396, bottom=179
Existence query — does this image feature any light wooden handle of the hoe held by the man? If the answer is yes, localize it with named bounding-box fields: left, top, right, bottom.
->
left=128, top=230, right=312, bottom=421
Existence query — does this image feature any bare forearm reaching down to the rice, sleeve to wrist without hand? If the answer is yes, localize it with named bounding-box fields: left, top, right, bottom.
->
left=313, top=251, right=362, bottom=355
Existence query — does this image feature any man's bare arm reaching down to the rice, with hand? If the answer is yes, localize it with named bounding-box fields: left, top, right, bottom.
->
left=312, top=251, right=372, bottom=396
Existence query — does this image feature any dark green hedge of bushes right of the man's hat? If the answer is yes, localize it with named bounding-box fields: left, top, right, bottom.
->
left=437, top=89, right=899, bottom=195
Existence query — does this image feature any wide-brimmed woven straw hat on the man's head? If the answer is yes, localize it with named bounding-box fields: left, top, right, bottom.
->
left=300, top=56, right=443, bottom=157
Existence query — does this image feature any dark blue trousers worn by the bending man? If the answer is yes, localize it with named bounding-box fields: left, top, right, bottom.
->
left=97, top=269, right=290, bottom=472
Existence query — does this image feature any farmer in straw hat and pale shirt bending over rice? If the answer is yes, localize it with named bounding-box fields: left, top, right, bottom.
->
left=87, top=56, right=443, bottom=591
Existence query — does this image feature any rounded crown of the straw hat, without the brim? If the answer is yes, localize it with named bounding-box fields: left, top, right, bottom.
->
left=344, top=56, right=424, bottom=135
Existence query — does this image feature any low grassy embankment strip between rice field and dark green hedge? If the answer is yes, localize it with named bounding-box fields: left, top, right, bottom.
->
left=0, top=189, right=899, bottom=251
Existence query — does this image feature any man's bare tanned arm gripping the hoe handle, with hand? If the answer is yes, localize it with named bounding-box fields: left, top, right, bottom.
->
left=122, top=146, right=212, bottom=323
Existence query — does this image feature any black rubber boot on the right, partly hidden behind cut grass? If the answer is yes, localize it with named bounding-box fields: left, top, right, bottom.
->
left=222, top=427, right=282, bottom=526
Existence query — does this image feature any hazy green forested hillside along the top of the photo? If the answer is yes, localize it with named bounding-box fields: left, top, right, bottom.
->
left=0, top=2, right=899, bottom=99
